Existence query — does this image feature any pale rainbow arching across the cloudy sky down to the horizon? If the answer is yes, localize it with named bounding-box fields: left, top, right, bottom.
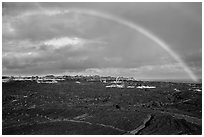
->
left=17, top=7, right=198, bottom=81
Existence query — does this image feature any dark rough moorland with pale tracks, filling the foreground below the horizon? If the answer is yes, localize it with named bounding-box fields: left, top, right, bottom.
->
left=2, top=81, right=202, bottom=135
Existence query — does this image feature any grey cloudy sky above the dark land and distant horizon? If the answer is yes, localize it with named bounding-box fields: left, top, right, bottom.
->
left=2, top=2, right=202, bottom=80
